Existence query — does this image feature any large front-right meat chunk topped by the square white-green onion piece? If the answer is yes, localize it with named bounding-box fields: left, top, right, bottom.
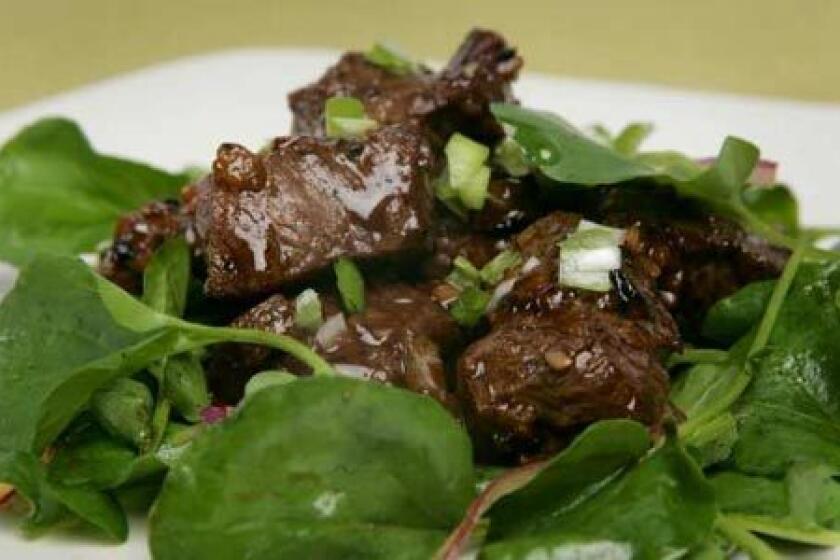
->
left=457, top=212, right=679, bottom=460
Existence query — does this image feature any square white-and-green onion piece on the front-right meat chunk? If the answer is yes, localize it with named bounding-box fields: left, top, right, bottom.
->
left=558, top=220, right=624, bottom=292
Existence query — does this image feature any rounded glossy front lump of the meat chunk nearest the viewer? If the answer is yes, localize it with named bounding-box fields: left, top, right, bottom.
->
left=458, top=302, right=668, bottom=460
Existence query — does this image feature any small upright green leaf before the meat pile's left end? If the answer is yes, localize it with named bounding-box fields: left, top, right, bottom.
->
left=143, top=237, right=190, bottom=317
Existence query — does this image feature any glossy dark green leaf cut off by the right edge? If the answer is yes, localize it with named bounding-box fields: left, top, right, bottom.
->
left=733, top=262, right=840, bottom=476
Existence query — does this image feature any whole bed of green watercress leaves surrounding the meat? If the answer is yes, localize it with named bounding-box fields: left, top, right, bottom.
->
left=0, top=104, right=840, bottom=560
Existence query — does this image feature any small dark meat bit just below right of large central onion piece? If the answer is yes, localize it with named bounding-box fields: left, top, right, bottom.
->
left=470, top=177, right=540, bottom=234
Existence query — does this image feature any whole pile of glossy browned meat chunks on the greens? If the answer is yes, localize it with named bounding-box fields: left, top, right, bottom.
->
left=101, top=30, right=787, bottom=462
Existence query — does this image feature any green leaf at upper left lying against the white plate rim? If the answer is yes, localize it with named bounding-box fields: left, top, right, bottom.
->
left=0, top=118, right=188, bottom=265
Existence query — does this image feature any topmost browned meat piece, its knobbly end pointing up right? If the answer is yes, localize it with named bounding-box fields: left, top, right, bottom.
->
left=289, top=29, right=522, bottom=140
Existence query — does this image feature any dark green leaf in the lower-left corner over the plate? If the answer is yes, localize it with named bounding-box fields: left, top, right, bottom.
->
left=0, top=450, right=128, bottom=542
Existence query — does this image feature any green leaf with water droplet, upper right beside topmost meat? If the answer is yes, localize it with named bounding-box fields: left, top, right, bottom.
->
left=491, top=103, right=655, bottom=186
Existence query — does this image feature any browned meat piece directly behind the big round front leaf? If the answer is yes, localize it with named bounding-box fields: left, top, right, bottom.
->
left=208, top=284, right=461, bottom=408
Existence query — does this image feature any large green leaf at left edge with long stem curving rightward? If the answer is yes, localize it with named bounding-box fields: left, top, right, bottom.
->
left=0, top=255, right=332, bottom=454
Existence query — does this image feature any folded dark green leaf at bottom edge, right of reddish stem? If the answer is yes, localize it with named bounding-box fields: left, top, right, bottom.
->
left=482, top=421, right=716, bottom=559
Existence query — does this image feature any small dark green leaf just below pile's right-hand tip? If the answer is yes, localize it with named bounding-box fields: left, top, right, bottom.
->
left=701, top=280, right=776, bottom=344
